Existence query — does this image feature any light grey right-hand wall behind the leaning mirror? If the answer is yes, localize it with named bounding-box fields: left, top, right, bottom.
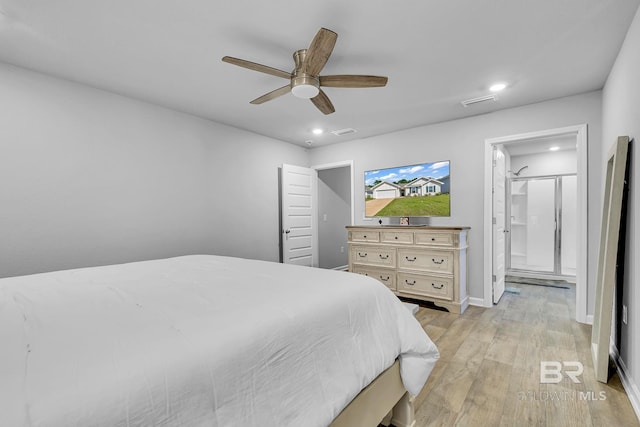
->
left=597, top=5, right=640, bottom=417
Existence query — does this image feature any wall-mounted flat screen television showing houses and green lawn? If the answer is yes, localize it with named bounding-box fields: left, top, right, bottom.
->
left=364, top=160, right=451, bottom=218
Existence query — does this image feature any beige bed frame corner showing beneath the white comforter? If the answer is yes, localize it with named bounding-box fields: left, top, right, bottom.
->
left=329, top=360, right=416, bottom=427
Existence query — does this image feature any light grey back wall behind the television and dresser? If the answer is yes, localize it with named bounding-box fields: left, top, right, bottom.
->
left=310, top=91, right=602, bottom=312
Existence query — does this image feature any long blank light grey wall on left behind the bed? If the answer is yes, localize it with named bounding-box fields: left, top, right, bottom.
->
left=0, top=64, right=308, bottom=277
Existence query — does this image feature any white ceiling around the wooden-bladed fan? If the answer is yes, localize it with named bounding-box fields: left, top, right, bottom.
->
left=0, top=0, right=640, bottom=146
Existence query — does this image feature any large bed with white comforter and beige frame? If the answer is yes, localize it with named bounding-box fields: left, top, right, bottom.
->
left=0, top=255, right=438, bottom=427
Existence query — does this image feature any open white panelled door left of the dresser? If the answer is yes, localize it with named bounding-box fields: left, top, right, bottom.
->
left=280, top=164, right=318, bottom=267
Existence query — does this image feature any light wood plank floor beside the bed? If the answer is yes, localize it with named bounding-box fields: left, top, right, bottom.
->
left=416, top=285, right=640, bottom=427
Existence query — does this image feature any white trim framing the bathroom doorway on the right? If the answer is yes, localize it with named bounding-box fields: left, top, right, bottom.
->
left=483, top=124, right=593, bottom=323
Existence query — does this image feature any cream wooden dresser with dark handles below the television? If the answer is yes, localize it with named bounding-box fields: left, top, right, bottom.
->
left=347, top=225, right=469, bottom=313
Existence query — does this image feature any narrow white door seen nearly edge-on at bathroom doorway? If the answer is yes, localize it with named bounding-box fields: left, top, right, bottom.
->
left=493, top=146, right=508, bottom=304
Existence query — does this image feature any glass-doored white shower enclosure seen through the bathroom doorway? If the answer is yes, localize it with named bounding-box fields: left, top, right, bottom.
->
left=507, top=174, right=577, bottom=279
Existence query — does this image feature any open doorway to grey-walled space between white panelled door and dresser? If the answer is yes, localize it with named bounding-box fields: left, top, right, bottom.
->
left=312, top=161, right=355, bottom=270
